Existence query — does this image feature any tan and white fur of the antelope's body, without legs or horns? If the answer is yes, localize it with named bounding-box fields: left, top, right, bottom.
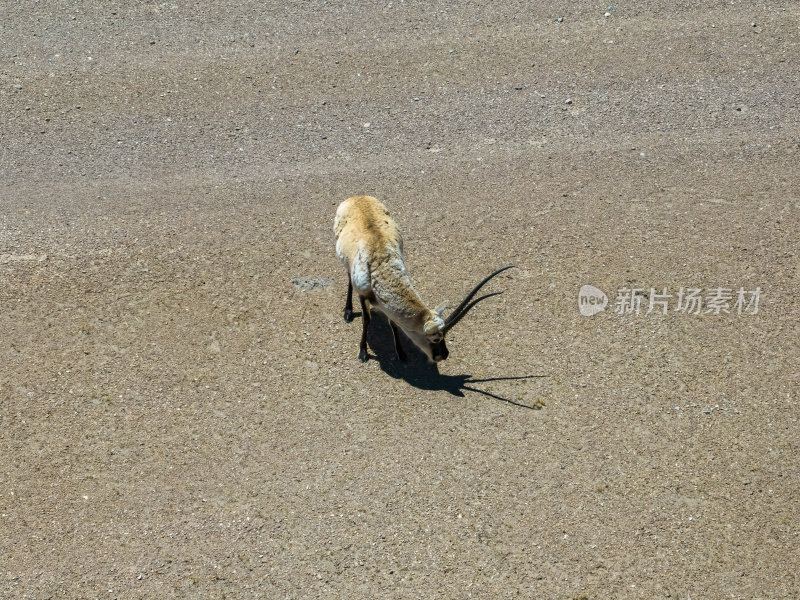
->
left=334, top=196, right=444, bottom=353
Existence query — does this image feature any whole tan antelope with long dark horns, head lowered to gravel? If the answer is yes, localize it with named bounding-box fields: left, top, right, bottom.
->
left=333, top=196, right=514, bottom=362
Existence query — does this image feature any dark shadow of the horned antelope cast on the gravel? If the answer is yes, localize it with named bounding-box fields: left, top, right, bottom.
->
left=360, top=310, right=547, bottom=410
